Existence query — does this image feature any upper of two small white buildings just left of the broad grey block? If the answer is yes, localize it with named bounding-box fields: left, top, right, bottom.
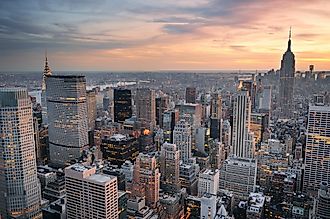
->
left=198, top=169, right=219, bottom=197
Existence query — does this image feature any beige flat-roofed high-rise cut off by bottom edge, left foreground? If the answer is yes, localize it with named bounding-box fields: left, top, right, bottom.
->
left=65, top=164, right=118, bottom=219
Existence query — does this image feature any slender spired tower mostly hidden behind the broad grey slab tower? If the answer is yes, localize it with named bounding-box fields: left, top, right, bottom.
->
left=41, top=54, right=52, bottom=125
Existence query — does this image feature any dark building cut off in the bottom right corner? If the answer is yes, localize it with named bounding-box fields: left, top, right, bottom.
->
left=315, top=182, right=330, bottom=219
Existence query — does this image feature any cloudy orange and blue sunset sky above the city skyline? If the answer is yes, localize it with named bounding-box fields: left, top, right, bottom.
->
left=0, top=0, right=330, bottom=72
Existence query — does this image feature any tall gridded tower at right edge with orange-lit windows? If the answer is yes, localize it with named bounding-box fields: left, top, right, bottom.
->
left=303, top=105, right=330, bottom=194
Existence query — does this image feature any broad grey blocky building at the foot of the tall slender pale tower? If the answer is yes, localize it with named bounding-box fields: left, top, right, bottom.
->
left=219, top=157, right=257, bottom=200
